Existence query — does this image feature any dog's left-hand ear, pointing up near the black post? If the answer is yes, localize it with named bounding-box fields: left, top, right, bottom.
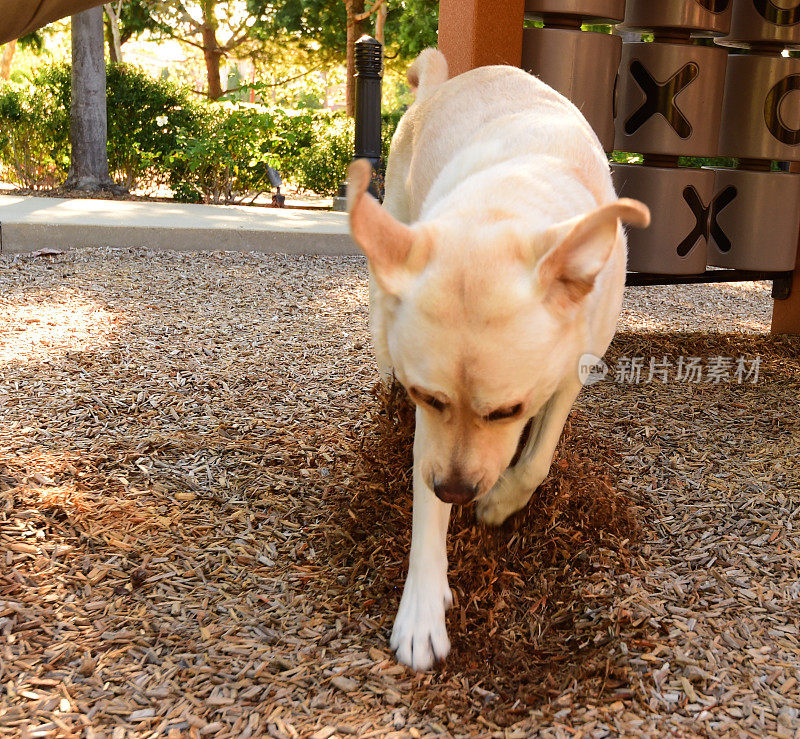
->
left=347, top=159, right=427, bottom=295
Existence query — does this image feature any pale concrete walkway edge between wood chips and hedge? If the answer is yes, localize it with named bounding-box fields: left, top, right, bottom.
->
left=0, top=195, right=360, bottom=254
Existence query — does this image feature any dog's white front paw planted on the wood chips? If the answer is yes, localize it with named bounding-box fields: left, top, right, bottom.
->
left=390, top=574, right=453, bottom=671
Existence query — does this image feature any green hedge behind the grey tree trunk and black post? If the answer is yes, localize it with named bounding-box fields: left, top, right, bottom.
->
left=0, top=59, right=410, bottom=203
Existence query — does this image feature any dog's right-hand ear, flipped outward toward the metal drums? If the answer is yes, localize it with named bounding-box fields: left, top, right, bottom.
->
left=537, top=198, right=650, bottom=307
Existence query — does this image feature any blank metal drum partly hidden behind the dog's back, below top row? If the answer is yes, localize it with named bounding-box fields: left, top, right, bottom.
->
left=522, top=28, right=622, bottom=151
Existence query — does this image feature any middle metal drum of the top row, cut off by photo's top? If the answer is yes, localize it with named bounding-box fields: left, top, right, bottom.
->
left=622, top=0, right=731, bottom=36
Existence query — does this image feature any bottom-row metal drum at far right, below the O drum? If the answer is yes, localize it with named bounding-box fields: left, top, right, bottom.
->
left=708, top=168, right=800, bottom=272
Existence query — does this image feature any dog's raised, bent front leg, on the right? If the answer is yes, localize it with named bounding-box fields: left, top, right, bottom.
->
left=475, top=381, right=581, bottom=526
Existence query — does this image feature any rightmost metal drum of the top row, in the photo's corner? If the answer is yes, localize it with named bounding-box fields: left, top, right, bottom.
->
left=718, top=0, right=800, bottom=50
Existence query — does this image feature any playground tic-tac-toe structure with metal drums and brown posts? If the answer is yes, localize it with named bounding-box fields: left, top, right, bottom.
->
left=432, top=0, right=800, bottom=333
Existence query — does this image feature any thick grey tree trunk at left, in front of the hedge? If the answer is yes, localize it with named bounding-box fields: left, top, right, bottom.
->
left=64, top=7, right=113, bottom=190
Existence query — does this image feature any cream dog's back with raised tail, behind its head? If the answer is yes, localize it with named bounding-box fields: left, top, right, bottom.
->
left=386, top=55, right=615, bottom=230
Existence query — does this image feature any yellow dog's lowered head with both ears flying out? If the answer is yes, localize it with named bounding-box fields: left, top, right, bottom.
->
left=348, top=160, right=649, bottom=504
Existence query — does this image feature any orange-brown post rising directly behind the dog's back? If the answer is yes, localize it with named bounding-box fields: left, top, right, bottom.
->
left=439, top=0, right=525, bottom=77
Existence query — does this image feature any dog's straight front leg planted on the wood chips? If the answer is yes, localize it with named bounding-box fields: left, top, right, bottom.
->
left=391, top=411, right=453, bottom=670
